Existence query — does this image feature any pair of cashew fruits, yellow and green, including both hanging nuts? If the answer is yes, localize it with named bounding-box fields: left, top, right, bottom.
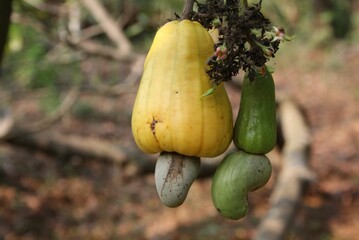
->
left=131, top=20, right=276, bottom=212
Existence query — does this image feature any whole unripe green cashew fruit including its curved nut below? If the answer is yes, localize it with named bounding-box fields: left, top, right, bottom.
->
left=211, top=67, right=277, bottom=219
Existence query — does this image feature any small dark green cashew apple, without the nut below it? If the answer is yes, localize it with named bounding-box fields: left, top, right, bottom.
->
left=233, top=70, right=277, bottom=154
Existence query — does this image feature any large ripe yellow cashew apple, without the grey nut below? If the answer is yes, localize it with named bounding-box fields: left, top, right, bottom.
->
left=132, top=20, right=233, bottom=157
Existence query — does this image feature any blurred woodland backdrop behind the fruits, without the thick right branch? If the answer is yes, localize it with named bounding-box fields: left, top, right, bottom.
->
left=0, top=0, right=359, bottom=240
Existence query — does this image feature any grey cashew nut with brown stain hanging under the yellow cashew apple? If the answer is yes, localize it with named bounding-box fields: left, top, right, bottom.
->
left=155, top=152, right=200, bottom=208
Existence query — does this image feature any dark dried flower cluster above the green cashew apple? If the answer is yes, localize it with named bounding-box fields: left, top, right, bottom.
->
left=193, top=0, right=285, bottom=85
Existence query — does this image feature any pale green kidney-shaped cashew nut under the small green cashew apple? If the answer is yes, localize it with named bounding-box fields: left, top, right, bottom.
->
left=211, top=151, right=272, bottom=220
